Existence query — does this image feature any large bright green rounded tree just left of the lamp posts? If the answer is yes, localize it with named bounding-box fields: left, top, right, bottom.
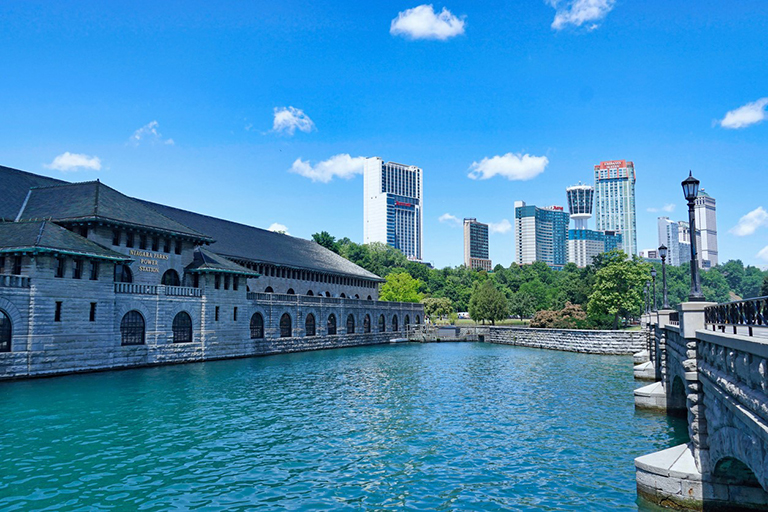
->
left=587, top=250, right=650, bottom=329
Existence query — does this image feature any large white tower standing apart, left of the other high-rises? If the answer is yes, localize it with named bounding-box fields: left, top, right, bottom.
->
left=363, top=157, right=423, bottom=261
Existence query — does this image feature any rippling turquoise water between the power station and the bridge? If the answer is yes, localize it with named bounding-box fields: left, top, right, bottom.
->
left=0, top=343, right=685, bottom=510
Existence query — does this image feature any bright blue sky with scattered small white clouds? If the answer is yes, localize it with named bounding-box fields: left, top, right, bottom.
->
left=0, top=0, right=768, bottom=267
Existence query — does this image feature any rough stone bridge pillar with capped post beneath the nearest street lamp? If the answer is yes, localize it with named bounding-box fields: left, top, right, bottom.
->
left=679, top=302, right=714, bottom=474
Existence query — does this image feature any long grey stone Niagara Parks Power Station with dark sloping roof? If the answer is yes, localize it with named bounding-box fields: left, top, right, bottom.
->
left=0, top=167, right=423, bottom=378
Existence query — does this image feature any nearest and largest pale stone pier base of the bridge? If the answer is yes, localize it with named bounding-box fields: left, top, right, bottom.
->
left=635, top=444, right=768, bottom=511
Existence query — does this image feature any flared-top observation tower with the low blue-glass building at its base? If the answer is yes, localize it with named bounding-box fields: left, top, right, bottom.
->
left=565, top=184, right=622, bottom=267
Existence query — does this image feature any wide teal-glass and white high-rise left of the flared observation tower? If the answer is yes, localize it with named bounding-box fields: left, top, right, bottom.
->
left=515, top=201, right=568, bottom=269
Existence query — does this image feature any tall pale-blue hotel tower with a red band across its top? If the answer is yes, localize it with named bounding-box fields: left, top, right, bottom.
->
left=595, top=160, right=637, bottom=256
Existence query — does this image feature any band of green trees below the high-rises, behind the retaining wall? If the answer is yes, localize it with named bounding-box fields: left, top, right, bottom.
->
left=312, top=231, right=768, bottom=328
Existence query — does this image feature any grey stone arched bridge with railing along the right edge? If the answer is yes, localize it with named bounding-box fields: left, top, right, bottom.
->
left=635, top=298, right=768, bottom=510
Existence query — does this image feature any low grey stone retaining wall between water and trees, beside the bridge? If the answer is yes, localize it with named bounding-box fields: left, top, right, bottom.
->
left=486, top=327, right=648, bottom=355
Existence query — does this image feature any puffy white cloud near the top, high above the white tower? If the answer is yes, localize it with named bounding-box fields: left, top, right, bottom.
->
left=389, top=4, right=464, bottom=41
